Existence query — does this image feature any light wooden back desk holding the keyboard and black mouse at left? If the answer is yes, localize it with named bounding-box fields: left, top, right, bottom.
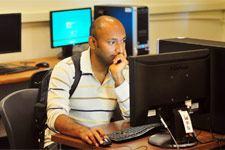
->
left=0, top=57, right=60, bottom=84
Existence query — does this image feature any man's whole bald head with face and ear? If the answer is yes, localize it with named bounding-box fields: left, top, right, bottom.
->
left=88, top=16, right=126, bottom=68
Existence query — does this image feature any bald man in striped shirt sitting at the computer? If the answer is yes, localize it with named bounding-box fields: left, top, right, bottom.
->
left=45, top=16, right=130, bottom=147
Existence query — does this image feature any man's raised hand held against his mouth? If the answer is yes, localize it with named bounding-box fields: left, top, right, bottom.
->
left=109, top=50, right=128, bottom=87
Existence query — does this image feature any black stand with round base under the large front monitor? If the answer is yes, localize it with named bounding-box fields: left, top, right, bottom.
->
left=148, top=108, right=198, bottom=149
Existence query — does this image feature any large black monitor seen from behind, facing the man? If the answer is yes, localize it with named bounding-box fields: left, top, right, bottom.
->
left=129, top=49, right=210, bottom=148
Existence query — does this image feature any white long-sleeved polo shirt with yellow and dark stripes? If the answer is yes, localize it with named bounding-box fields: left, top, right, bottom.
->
left=45, top=49, right=130, bottom=145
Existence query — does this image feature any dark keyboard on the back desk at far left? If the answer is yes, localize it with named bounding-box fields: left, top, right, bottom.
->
left=0, top=66, right=39, bottom=75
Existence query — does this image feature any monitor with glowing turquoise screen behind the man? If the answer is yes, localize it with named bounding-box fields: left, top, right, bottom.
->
left=50, top=8, right=92, bottom=58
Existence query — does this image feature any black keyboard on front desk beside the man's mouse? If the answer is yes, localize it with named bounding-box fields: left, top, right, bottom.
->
left=107, top=123, right=163, bottom=142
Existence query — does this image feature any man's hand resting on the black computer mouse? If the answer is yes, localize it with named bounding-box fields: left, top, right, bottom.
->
left=80, top=127, right=108, bottom=147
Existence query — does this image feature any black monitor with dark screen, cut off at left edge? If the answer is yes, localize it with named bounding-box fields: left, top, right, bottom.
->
left=0, top=13, right=21, bottom=53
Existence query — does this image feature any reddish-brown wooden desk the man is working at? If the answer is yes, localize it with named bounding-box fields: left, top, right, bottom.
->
left=52, top=120, right=225, bottom=149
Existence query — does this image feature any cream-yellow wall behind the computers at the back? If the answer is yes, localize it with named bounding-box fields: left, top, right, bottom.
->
left=0, top=0, right=225, bottom=63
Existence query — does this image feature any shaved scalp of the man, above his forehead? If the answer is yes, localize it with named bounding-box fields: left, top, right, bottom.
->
left=90, top=16, right=124, bottom=39
